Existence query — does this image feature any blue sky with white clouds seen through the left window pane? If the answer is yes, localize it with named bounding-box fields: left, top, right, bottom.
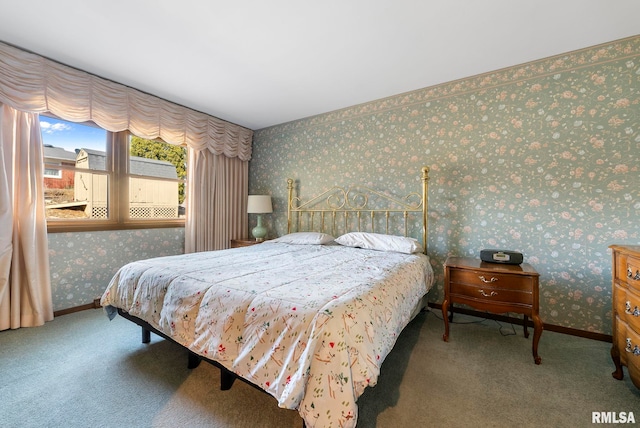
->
left=40, top=116, right=107, bottom=152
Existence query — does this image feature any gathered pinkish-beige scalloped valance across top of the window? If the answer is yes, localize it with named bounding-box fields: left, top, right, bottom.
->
left=0, top=42, right=253, bottom=162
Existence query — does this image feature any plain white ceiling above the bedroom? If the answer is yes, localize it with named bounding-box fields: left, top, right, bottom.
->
left=0, top=0, right=640, bottom=129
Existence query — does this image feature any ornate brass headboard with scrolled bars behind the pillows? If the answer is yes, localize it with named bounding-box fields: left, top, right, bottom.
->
left=287, top=166, right=429, bottom=253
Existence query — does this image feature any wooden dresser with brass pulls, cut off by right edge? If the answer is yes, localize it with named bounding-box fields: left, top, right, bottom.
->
left=609, top=245, right=640, bottom=388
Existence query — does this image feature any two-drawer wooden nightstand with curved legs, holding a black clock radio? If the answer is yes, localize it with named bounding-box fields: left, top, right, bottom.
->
left=442, top=257, right=542, bottom=364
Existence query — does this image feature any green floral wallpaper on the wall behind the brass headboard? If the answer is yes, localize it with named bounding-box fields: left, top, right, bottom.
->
left=249, top=36, right=640, bottom=334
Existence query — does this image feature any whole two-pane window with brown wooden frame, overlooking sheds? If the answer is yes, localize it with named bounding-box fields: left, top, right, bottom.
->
left=40, top=116, right=186, bottom=232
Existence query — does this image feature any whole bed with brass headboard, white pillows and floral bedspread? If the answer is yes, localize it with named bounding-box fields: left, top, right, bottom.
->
left=101, top=167, right=433, bottom=427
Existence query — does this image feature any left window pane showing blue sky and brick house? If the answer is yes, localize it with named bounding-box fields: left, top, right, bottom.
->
left=40, top=116, right=109, bottom=219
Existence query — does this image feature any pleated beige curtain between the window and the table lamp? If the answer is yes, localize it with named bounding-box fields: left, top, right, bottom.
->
left=185, top=150, right=249, bottom=253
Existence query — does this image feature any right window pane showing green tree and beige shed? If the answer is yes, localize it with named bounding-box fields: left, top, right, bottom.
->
left=129, top=136, right=187, bottom=220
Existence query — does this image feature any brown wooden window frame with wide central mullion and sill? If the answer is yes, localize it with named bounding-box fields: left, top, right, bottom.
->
left=42, top=114, right=188, bottom=233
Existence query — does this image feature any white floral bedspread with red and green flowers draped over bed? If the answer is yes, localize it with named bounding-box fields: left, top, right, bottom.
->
left=101, top=242, right=433, bottom=427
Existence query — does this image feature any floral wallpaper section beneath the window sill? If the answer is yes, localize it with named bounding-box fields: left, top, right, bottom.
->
left=48, top=228, right=184, bottom=311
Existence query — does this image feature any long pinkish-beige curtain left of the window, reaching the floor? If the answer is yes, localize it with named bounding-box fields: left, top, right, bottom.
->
left=0, top=103, right=53, bottom=330
